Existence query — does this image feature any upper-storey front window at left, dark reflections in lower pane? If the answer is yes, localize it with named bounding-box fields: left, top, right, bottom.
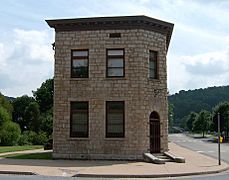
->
left=71, top=50, right=88, bottom=78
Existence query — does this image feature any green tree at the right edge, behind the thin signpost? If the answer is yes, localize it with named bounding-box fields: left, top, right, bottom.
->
left=213, top=101, right=229, bottom=141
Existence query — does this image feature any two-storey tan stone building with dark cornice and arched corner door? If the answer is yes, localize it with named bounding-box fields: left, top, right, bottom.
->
left=47, top=16, right=173, bottom=159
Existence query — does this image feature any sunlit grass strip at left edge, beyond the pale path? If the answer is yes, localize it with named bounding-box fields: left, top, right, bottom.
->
left=0, top=145, right=43, bottom=155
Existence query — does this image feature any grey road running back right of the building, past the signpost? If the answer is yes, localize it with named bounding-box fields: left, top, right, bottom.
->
left=169, top=134, right=229, bottom=163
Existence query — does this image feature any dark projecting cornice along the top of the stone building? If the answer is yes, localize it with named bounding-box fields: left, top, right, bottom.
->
left=46, top=16, right=174, bottom=48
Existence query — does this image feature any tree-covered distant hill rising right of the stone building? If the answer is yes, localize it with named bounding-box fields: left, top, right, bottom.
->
left=168, top=86, right=229, bottom=123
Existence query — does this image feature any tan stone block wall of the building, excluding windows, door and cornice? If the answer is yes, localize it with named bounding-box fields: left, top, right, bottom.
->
left=53, top=29, right=168, bottom=159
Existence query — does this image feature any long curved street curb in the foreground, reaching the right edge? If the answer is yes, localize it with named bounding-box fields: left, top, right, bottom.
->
left=72, top=166, right=229, bottom=178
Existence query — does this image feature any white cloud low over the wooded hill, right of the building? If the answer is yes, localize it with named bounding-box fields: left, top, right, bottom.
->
left=168, top=45, right=229, bottom=94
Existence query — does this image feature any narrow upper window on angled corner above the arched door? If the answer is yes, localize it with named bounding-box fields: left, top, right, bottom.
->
left=149, top=51, right=158, bottom=79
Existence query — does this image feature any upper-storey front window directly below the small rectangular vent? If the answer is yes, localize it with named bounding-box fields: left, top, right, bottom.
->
left=107, top=49, right=125, bottom=77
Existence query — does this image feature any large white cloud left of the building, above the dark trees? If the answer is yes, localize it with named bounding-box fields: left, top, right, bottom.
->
left=0, top=29, right=54, bottom=96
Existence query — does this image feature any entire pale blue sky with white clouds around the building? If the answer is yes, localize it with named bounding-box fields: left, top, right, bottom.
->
left=0, top=0, right=229, bottom=97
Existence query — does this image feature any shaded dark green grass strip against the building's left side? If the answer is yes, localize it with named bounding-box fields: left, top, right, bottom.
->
left=3, top=152, right=52, bottom=160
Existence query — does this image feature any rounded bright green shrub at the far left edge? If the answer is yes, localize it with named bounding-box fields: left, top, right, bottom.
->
left=0, top=121, right=21, bottom=146
